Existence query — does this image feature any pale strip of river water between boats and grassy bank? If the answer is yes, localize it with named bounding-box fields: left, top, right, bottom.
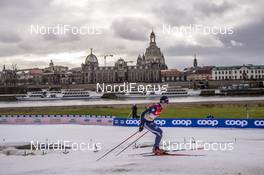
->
left=0, top=96, right=264, bottom=108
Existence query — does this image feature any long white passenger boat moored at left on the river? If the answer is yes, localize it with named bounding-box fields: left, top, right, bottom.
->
left=16, top=89, right=103, bottom=101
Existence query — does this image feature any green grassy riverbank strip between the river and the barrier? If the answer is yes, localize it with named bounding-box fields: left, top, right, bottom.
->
left=0, top=100, right=264, bottom=118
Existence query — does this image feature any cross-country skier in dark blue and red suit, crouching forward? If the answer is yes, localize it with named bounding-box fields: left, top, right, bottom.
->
left=139, top=96, right=169, bottom=155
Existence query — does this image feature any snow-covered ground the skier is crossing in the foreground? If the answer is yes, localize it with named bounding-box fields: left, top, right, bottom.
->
left=0, top=125, right=264, bottom=175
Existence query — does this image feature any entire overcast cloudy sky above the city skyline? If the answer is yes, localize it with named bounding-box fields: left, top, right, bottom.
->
left=0, top=0, right=264, bottom=70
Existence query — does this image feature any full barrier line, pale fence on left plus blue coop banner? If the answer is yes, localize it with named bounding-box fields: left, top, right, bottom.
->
left=0, top=115, right=264, bottom=128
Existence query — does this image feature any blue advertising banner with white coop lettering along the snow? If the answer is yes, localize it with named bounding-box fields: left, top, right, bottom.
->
left=113, top=118, right=264, bottom=128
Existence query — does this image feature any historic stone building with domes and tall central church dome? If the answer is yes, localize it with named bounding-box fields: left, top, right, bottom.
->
left=81, top=31, right=167, bottom=83
